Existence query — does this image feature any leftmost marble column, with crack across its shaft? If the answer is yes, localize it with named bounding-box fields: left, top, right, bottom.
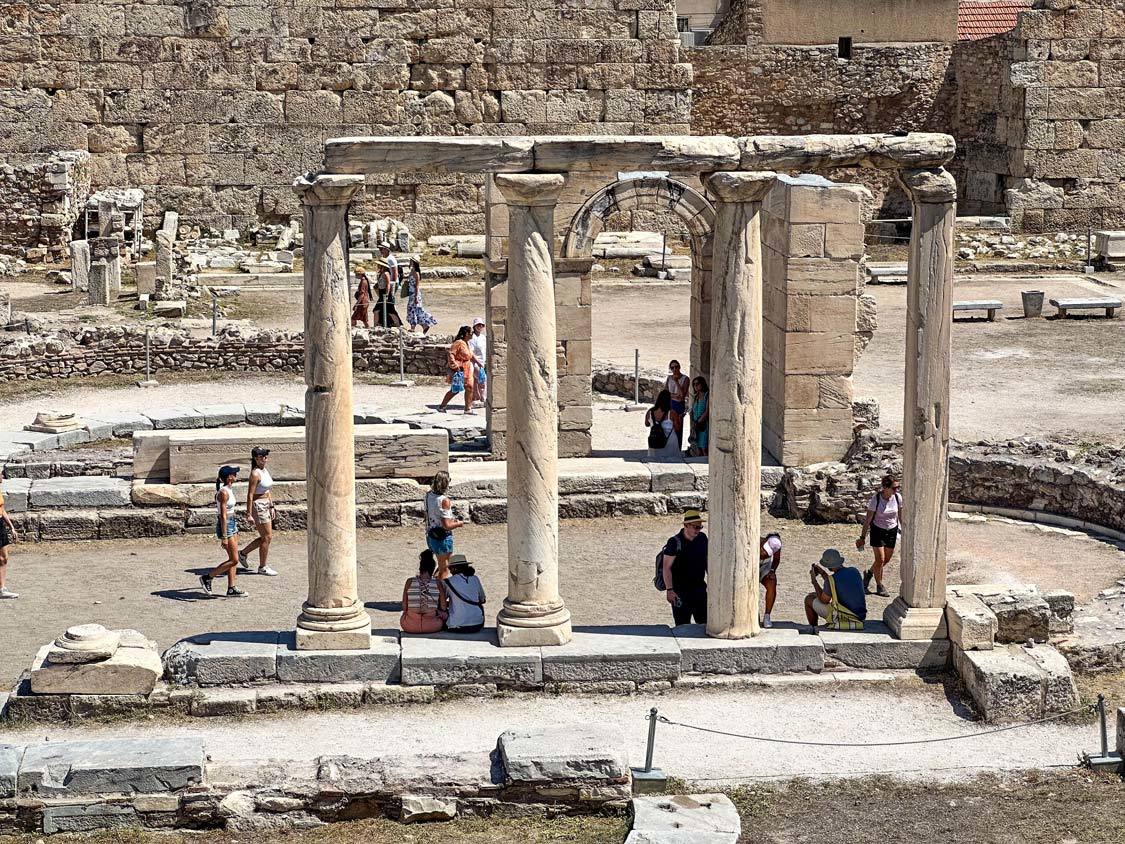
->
left=294, top=174, right=371, bottom=650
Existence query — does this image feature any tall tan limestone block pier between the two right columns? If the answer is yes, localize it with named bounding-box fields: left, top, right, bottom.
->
left=762, top=176, right=865, bottom=466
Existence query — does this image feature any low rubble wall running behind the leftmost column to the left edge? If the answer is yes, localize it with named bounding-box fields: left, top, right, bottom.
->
left=0, top=326, right=449, bottom=380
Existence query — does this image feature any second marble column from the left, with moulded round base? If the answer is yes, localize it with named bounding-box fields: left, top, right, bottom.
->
left=495, top=173, right=570, bottom=647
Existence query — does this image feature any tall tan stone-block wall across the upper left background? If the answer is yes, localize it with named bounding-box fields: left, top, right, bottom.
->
left=0, top=0, right=691, bottom=236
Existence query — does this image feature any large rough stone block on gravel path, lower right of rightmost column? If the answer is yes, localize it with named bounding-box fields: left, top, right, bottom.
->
left=953, top=645, right=1078, bottom=722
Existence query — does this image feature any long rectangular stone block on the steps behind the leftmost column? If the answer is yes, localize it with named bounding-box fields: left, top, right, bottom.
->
left=133, top=424, right=449, bottom=484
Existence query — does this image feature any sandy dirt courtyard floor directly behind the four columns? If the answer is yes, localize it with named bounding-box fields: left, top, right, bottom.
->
left=0, top=517, right=1125, bottom=685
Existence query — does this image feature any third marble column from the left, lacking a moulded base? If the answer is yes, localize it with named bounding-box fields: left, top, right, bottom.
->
left=703, top=172, right=775, bottom=639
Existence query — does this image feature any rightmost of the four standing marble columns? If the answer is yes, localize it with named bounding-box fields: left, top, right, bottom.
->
left=883, top=168, right=957, bottom=639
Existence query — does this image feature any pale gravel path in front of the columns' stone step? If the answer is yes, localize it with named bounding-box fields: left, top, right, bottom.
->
left=6, top=679, right=1097, bottom=787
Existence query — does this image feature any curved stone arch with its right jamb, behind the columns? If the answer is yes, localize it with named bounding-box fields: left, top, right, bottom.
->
left=561, top=176, right=714, bottom=380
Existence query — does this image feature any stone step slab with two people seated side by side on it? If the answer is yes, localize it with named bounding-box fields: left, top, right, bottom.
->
left=402, top=628, right=543, bottom=685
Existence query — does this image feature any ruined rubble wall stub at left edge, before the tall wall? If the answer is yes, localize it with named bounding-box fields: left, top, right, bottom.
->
left=0, top=151, right=90, bottom=260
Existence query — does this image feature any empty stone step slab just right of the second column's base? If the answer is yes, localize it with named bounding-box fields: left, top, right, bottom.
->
left=542, top=625, right=681, bottom=682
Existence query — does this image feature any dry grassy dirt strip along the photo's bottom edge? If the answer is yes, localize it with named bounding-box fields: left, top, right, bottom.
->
left=0, top=771, right=1125, bottom=844
